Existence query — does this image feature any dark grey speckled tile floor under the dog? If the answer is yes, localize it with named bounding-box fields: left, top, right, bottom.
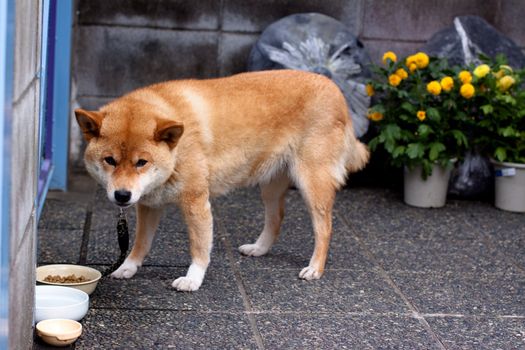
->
left=34, top=174, right=525, bottom=349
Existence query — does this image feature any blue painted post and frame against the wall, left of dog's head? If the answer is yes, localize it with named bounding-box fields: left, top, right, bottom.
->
left=37, top=0, right=73, bottom=217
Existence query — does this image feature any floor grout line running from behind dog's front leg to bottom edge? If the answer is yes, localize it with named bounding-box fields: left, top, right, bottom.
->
left=214, top=206, right=265, bottom=350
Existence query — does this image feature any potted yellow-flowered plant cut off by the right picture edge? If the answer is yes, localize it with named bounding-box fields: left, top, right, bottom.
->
left=470, top=56, right=525, bottom=212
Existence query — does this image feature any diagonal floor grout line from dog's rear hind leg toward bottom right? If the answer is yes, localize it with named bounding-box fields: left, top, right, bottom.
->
left=334, top=208, right=447, bottom=349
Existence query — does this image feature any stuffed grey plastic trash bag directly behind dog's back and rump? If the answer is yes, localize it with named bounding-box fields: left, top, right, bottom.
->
left=247, top=13, right=370, bottom=137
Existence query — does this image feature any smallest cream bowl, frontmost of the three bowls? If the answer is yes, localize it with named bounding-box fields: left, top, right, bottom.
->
left=36, top=319, right=82, bottom=346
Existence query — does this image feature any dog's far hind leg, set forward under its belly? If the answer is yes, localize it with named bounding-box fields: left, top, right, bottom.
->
left=239, top=172, right=290, bottom=256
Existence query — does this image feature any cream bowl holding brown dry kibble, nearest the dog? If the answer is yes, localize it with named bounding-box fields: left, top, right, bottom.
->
left=36, top=264, right=102, bottom=294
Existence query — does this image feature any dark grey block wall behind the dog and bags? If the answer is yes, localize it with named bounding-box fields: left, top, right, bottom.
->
left=73, top=0, right=525, bottom=165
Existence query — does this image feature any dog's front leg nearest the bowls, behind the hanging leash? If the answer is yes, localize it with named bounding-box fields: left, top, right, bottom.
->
left=111, top=204, right=162, bottom=278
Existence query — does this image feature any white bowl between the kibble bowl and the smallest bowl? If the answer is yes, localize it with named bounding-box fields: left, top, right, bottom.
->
left=35, top=286, right=89, bottom=322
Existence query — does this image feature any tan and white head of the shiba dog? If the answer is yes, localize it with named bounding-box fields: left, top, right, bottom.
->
left=75, top=104, right=184, bottom=207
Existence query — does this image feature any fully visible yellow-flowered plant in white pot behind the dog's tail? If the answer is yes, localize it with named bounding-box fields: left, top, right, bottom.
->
left=367, top=51, right=473, bottom=207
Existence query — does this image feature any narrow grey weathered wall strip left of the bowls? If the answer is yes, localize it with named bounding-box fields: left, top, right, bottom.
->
left=9, top=0, right=41, bottom=349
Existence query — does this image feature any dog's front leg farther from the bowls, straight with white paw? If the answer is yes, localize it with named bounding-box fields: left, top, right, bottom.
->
left=172, top=193, right=213, bottom=292
